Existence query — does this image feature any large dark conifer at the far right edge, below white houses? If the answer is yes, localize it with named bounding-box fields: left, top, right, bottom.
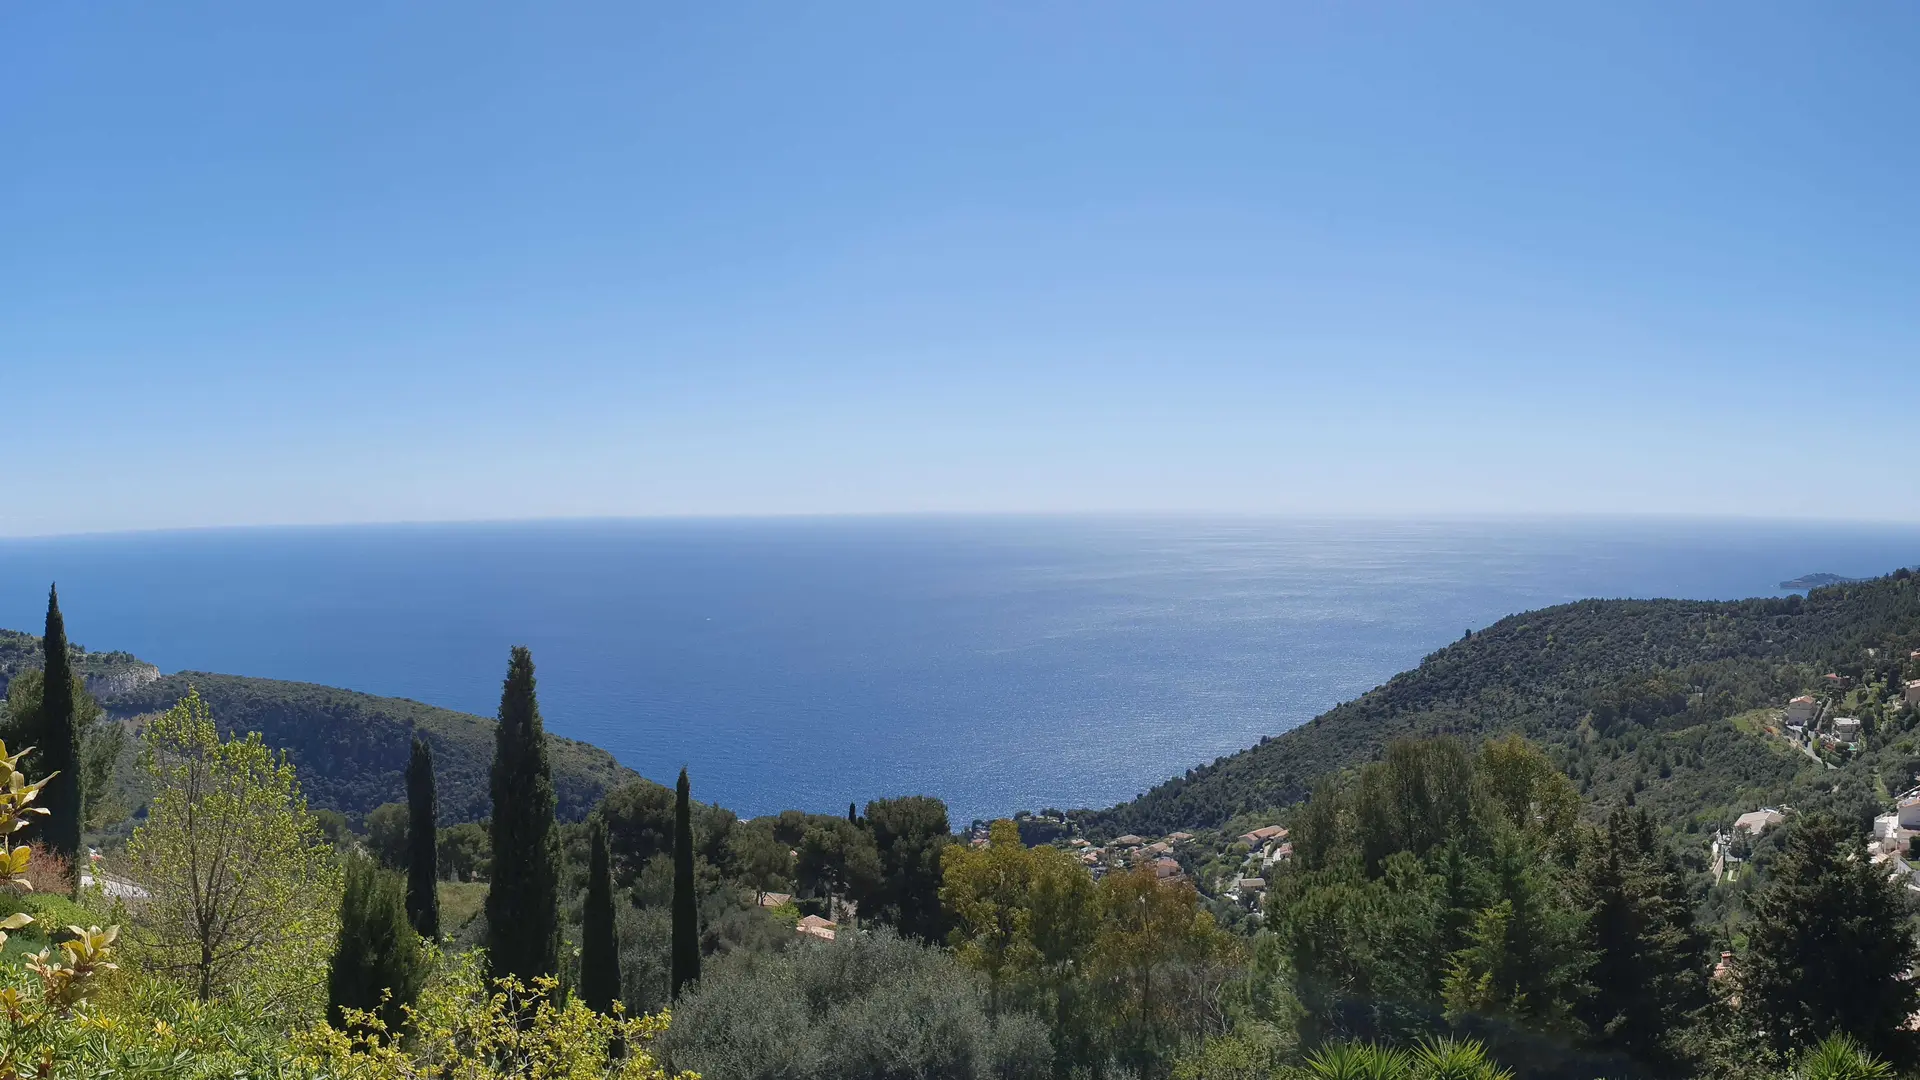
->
left=1738, top=815, right=1920, bottom=1063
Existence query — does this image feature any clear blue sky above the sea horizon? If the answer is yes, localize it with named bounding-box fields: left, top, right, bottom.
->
left=0, top=0, right=1920, bottom=534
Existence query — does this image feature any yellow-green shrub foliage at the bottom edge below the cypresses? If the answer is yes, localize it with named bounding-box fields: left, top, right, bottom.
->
left=296, top=953, right=699, bottom=1080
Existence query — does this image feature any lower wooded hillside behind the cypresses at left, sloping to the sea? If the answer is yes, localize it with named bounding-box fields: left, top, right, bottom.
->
left=102, top=671, right=636, bottom=824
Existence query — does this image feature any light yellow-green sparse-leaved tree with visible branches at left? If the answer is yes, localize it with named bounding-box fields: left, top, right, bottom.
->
left=127, top=694, right=340, bottom=1009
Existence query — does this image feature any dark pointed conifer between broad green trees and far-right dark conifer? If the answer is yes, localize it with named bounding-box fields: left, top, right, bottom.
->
left=1574, top=809, right=1707, bottom=1074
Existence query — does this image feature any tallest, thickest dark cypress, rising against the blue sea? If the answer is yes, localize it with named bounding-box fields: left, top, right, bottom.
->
left=486, top=646, right=561, bottom=982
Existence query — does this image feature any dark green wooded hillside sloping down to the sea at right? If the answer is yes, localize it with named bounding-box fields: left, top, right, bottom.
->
left=1081, top=571, right=1920, bottom=834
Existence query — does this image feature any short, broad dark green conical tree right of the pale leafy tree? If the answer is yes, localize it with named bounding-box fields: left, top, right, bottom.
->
left=326, top=855, right=426, bottom=1032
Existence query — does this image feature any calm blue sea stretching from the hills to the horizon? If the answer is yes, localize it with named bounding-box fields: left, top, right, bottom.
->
left=0, top=517, right=1920, bottom=824
